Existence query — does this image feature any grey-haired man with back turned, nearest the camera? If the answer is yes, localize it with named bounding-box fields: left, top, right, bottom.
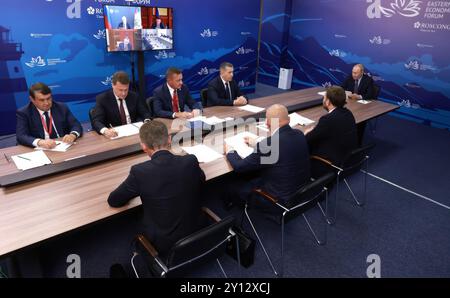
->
left=108, top=121, right=205, bottom=253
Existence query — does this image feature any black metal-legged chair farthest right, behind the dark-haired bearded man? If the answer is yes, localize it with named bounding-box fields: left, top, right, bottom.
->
left=311, top=144, right=375, bottom=223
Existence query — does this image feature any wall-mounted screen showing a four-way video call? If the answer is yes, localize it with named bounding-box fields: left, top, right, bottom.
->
left=103, top=5, right=173, bottom=52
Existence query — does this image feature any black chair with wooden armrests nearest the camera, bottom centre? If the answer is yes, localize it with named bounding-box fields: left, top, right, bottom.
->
left=131, top=207, right=240, bottom=278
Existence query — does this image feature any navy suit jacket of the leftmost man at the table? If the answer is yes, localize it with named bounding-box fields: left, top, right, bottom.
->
left=16, top=101, right=83, bottom=147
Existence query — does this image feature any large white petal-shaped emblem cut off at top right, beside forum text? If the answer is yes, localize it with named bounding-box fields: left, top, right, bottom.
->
left=367, top=0, right=422, bottom=19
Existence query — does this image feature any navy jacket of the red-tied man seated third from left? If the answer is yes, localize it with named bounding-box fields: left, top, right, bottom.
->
left=153, top=83, right=202, bottom=119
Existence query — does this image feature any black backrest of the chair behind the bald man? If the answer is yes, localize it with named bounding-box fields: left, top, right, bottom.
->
left=286, top=172, right=336, bottom=208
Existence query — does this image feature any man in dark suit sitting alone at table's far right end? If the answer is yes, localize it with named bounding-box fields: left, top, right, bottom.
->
left=342, top=64, right=376, bottom=145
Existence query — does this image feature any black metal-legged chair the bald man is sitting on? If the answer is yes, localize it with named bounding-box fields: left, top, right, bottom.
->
left=244, top=172, right=336, bottom=276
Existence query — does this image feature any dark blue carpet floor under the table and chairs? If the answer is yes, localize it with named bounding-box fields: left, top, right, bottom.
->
left=0, top=85, right=450, bottom=277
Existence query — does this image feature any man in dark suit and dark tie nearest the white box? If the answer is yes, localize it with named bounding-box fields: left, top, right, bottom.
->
left=208, top=62, right=247, bottom=106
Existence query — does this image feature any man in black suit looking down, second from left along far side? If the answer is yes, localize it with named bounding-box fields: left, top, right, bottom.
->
left=92, top=71, right=151, bottom=138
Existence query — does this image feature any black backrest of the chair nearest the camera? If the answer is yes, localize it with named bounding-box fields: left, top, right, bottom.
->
left=166, top=216, right=234, bottom=272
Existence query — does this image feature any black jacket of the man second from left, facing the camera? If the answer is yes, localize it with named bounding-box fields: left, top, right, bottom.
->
left=92, top=89, right=151, bottom=133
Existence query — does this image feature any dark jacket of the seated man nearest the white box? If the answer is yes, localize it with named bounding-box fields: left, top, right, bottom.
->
left=207, top=76, right=247, bottom=107
